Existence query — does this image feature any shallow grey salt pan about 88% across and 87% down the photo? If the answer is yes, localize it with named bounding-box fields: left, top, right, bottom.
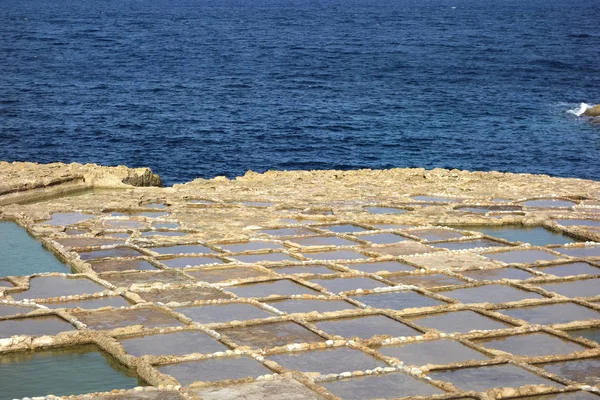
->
left=474, top=332, right=587, bottom=357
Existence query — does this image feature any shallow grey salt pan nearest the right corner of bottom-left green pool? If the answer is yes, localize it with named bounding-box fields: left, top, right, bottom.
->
left=158, top=356, right=272, bottom=385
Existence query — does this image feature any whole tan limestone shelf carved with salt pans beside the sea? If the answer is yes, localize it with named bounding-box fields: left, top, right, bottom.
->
left=0, top=163, right=600, bottom=400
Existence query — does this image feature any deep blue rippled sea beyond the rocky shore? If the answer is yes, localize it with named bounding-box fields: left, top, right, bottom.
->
left=0, top=0, right=600, bottom=184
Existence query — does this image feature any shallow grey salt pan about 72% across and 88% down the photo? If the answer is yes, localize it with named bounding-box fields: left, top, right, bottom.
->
left=376, top=339, right=489, bottom=366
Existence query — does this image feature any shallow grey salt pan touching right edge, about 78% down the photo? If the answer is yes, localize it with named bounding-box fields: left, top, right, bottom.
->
left=498, top=303, right=600, bottom=325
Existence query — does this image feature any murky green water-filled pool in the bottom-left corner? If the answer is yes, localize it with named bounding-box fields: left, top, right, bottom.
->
left=0, top=345, right=146, bottom=399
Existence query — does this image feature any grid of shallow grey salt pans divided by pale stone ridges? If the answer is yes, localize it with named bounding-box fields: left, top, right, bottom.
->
left=0, top=198, right=600, bottom=399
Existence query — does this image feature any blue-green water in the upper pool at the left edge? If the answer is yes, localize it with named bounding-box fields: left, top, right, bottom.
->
left=0, top=221, right=70, bottom=277
